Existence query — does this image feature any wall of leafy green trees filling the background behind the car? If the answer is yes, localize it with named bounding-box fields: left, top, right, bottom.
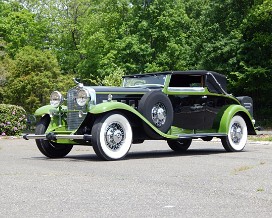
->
left=0, top=0, right=272, bottom=122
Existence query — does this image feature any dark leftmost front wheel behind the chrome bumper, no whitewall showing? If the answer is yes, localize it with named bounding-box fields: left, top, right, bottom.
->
left=35, top=115, right=73, bottom=158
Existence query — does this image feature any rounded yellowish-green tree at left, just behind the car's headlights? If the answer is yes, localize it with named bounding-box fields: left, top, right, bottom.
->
left=3, top=46, right=72, bottom=112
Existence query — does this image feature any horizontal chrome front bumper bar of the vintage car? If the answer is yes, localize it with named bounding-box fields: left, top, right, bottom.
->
left=23, top=132, right=92, bottom=141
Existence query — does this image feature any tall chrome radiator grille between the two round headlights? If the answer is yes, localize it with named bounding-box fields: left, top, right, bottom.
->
left=67, top=89, right=86, bottom=130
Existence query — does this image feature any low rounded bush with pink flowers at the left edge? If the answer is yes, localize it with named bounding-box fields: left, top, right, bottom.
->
left=0, top=104, right=26, bottom=136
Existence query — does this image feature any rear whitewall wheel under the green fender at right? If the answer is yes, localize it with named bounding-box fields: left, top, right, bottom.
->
left=221, top=115, right=247, bottom=152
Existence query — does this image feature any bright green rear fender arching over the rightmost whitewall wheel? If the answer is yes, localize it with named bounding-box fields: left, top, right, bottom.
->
left=216, top=105, right=256, bottom=135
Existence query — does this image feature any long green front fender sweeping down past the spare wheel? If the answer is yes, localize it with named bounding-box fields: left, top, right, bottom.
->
left=88, top=102, right=177, bottom=138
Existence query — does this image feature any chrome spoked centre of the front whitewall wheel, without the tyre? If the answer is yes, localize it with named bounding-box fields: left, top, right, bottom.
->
left=105, top=123, right=125, bottom=150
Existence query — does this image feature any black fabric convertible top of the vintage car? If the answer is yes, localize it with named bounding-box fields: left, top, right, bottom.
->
left=123, top=70, right=227, bottom=94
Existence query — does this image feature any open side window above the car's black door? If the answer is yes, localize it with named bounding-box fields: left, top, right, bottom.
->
left=169, top=74, right=204, bottom=88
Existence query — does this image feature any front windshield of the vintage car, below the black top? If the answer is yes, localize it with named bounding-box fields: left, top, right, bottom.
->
left=123, top=74, right=166, bottom=87
